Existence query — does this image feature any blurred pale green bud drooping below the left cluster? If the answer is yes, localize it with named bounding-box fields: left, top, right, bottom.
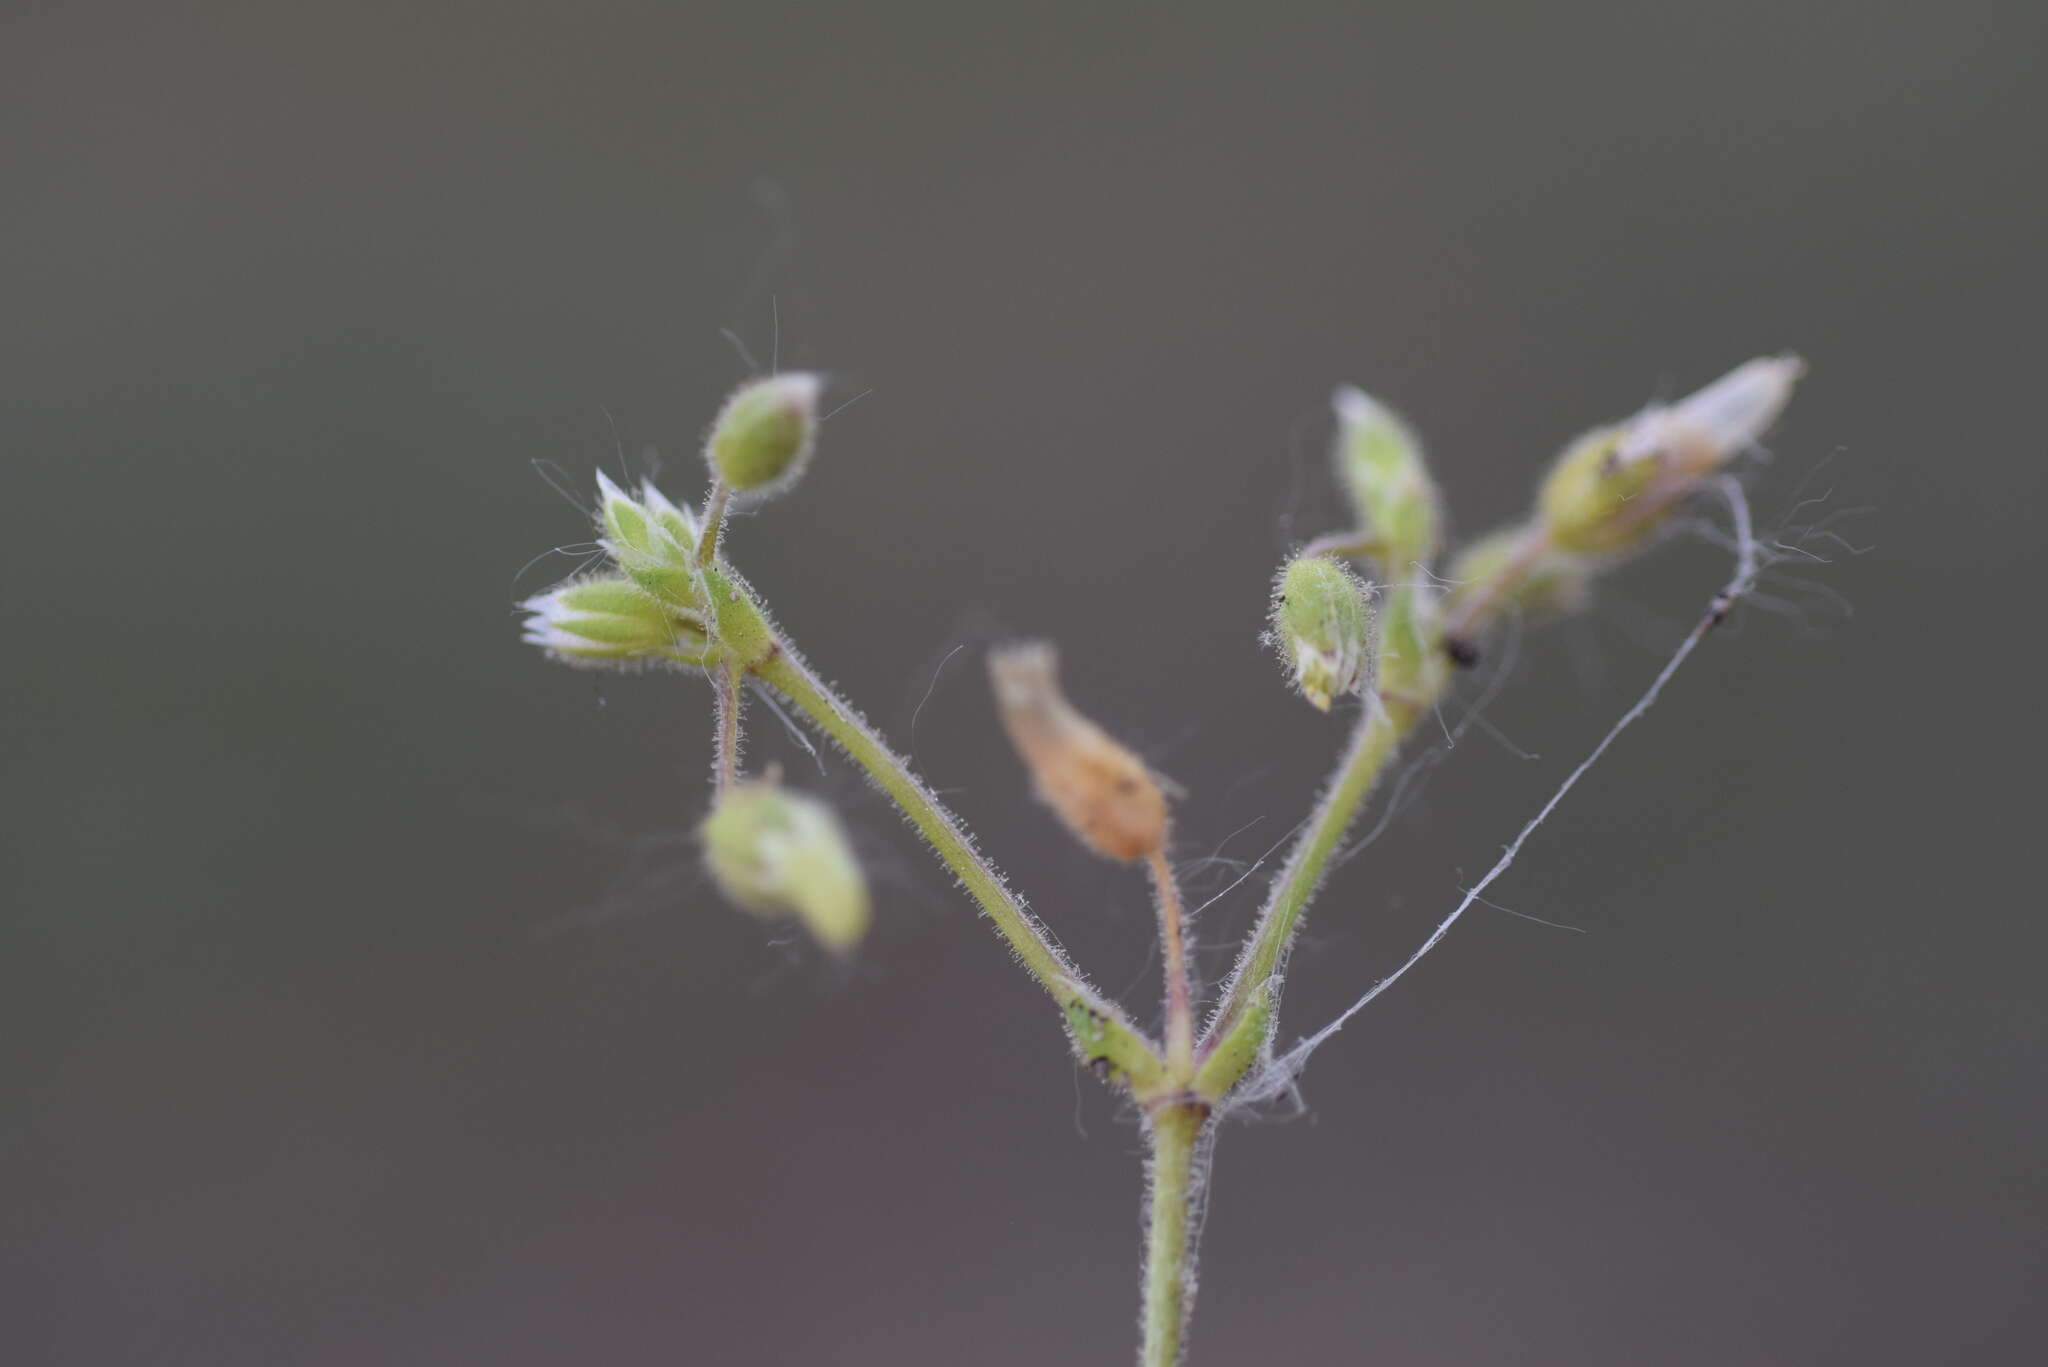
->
left=700, top=781, right=872, bottom=955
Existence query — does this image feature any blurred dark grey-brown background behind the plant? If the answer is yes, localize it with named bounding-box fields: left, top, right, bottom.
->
left=0, top=0, right=2048, bottom=1367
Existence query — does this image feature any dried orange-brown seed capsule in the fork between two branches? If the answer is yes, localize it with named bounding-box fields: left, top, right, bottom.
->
left=989, top=641, right=1165, bottom=859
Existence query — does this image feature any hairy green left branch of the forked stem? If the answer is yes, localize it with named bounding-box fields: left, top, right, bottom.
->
left=754, top=651, right=1169, bottom=1101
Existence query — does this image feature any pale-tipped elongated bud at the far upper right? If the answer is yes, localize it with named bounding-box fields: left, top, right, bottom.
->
left=1536, top=357, right=1806, bottom=555
